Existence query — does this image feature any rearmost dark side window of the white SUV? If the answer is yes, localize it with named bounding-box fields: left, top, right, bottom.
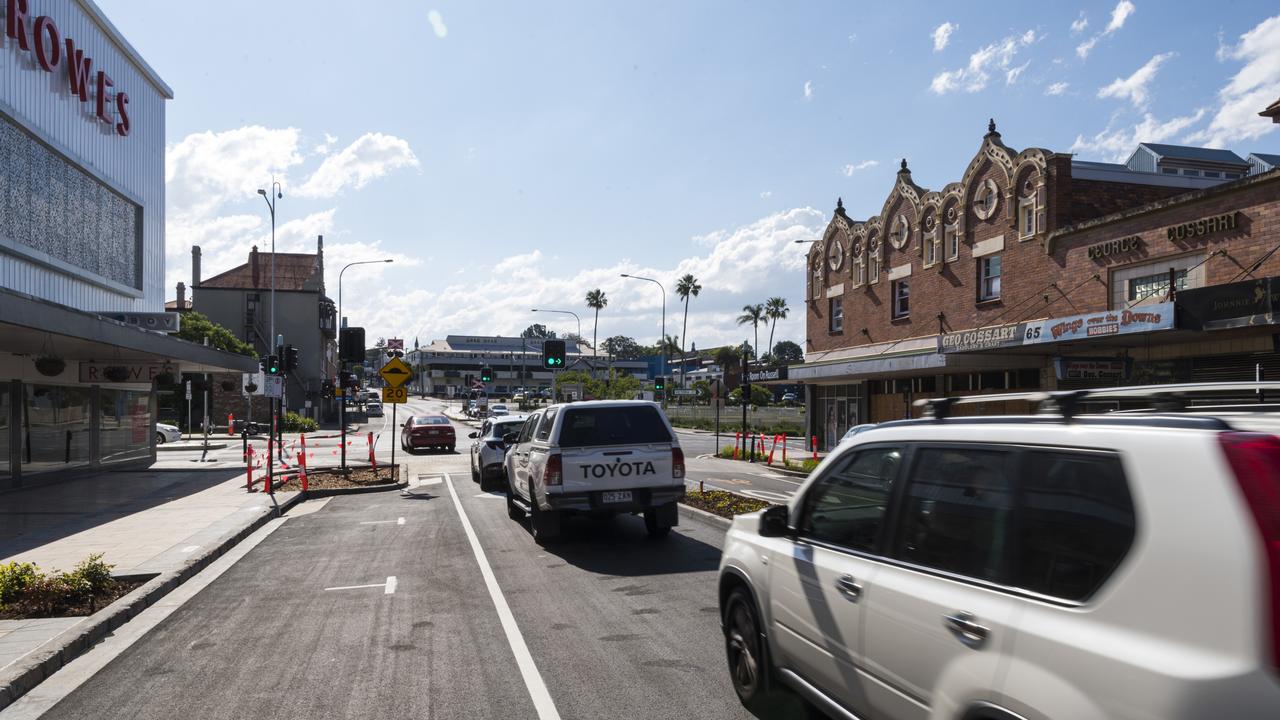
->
left=1012, top=451, right=1134, bottom=600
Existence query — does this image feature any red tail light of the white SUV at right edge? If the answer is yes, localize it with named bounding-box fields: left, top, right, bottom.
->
left=1219, top=433, right=1280, bottom=671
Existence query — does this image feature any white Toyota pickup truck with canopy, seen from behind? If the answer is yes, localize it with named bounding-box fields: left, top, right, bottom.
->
left=503, top=400, right=685, bottom=542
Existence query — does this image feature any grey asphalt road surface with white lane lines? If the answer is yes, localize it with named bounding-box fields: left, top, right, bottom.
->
left=24, top=407, right=799, bottom=720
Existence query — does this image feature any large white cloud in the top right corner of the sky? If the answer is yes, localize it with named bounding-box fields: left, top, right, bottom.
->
left=1187, top=15, right=1280, bottom=147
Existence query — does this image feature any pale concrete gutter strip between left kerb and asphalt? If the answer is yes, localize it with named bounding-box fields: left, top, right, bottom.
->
left=0, top=518, right=288, bottom=720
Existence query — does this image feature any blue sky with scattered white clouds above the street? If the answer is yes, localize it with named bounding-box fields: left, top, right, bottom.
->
left=99, top=0, right=1280, bottom=347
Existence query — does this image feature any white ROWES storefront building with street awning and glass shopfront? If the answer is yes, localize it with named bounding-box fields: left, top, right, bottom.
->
left=0, top=0, right=255, bottom=489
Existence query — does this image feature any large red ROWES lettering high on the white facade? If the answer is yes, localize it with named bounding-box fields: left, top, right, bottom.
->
left=0, top=0, right=129, bottom=137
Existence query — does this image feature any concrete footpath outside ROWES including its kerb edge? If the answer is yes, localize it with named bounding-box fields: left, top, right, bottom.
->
left=0, top=468, right=297, bottom=708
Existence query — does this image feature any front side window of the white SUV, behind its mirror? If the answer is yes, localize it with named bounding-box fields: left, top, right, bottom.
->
left=799, top=447, right=902, bottom=552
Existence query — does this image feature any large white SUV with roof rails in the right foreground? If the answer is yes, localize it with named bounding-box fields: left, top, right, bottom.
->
left=718, top=383, right=1280, bottom=720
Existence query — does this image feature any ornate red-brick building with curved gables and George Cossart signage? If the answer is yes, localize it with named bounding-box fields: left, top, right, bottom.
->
left=790, top=123, right=1280, bottom=446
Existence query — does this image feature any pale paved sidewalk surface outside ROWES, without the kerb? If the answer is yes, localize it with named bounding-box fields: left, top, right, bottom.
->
left=0, top=468, right=294, bottom=678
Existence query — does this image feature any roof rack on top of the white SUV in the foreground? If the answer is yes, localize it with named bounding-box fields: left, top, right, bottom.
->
left=915, top=380, right=1280, bottom=420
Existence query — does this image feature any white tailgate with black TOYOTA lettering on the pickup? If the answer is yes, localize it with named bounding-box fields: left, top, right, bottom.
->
left=561, top=443, right=684, bottom=492
